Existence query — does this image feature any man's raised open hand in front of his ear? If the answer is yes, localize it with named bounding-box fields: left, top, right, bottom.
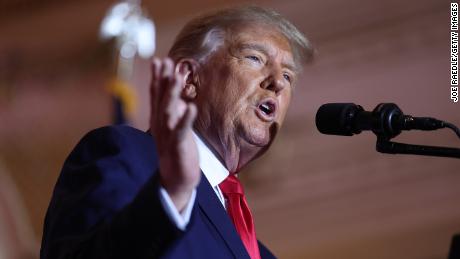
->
left=150, top=58, right=201, bottom=211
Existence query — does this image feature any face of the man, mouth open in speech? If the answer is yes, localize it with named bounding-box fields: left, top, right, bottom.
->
left=197, top=24, right=296, bottom=167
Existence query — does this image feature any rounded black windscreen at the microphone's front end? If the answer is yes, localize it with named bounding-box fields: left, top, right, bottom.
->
left=315, top=103, right=363, bottom=136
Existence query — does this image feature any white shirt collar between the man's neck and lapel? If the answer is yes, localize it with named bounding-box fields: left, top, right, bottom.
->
left=193, top=132, right=229, bottom=187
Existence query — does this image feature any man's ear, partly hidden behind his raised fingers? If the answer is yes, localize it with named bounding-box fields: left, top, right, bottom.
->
left=176, top=58, right=200, bottom=101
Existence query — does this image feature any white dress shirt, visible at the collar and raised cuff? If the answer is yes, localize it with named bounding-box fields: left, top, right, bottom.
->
left=160, top=132, right=229, bottom=230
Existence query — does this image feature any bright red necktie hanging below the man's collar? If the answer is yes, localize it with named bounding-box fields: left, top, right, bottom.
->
left=219, top=174, right=260, bottom=259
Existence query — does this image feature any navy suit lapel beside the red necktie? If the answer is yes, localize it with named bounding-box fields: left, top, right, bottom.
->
left=197, top=174, right=249, bottom=258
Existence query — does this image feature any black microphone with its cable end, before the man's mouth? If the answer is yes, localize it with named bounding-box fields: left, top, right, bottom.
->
left=316, top=103, right=446, bottom=139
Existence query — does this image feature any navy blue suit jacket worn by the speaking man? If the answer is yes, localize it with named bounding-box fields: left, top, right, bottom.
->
left=40, top=126, right=274, bottom=259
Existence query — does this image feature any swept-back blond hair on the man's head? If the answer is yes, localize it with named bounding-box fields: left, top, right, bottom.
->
left=168, top=6, right=314, bottom=70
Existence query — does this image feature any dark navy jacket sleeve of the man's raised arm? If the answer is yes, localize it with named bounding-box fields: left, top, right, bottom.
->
left=40, top=126, right=188, bottom=259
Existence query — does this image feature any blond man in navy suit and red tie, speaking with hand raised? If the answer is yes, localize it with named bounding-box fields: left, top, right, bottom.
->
left=40, top=7, right=312, bottom=259
